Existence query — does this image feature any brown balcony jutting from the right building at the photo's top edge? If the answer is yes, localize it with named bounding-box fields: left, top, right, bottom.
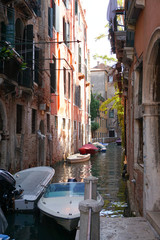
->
left=126, top=0, right=145, bottom=25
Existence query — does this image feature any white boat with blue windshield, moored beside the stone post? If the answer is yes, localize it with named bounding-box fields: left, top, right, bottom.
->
left=38, top=182, right=85, bottom=231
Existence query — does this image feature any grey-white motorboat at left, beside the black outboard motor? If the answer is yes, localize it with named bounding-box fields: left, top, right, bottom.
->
left=13, top=166, right=55, bottom=211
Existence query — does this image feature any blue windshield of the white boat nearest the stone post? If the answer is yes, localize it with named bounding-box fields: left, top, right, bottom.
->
left=44, top=182, right=84, bottom=198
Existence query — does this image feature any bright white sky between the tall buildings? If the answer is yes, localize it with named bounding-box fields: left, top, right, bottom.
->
left=83, top=0, right=114, bottom=68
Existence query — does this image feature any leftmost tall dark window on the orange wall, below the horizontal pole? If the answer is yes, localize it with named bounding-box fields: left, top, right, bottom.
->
left=50, top=57, right=57, bottom=93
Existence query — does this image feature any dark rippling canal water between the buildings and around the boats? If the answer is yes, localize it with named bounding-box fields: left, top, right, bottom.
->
left=6, top=143, right=127, bottom=240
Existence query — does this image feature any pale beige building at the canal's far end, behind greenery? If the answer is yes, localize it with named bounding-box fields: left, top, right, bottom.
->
left=90, top=63, right=120, bottom=142
